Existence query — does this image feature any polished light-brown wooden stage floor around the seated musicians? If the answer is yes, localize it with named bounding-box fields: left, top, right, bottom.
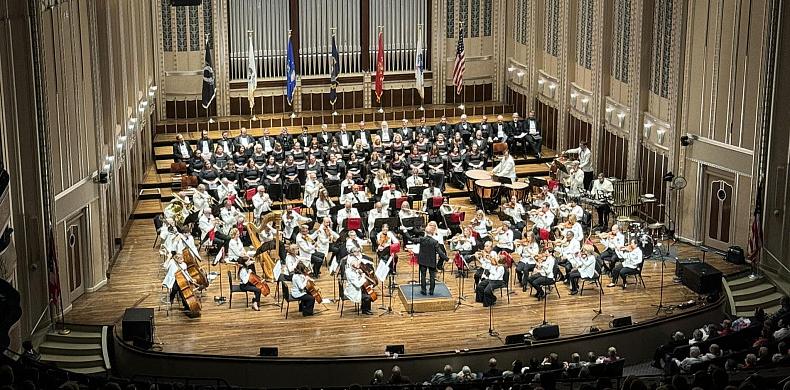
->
left=66, top=203, right=741, bottom=357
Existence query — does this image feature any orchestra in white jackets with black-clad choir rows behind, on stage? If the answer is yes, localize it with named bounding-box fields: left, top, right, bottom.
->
left=157, top=118, right=664, bottom=316
